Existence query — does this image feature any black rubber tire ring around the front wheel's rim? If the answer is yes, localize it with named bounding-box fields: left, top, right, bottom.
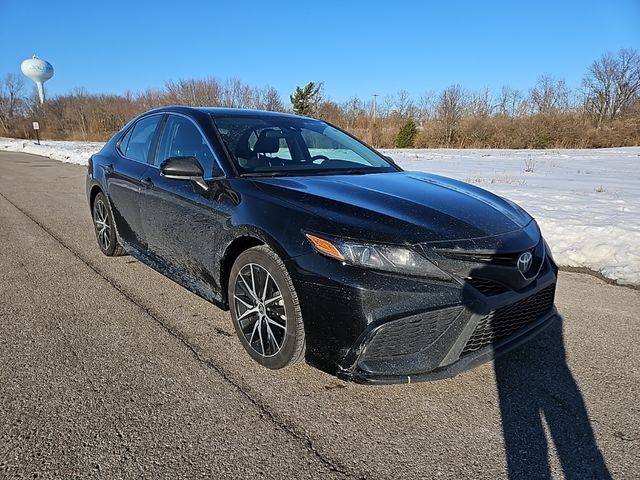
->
left=227, top=247, right=301, bottom=369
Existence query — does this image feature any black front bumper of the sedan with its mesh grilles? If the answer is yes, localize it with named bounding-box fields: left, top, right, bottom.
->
left=289, top=246, right=557, bottom=384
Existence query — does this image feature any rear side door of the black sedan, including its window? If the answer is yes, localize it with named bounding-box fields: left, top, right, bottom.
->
left=105, top=114, right=163, bottom=251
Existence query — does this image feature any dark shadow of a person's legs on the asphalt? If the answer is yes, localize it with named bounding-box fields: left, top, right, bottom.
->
left=494, top=316, right=611, bottom=480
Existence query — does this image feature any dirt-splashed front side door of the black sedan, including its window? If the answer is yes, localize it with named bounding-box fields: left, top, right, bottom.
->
left=142, top=114, right=233, bottom=298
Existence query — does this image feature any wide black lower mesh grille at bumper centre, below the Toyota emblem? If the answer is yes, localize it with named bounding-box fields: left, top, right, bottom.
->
left=462, top=285, right=556, bottom=355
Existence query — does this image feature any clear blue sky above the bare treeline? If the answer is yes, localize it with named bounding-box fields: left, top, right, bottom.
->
left=0, top=0, right=640, bottom=101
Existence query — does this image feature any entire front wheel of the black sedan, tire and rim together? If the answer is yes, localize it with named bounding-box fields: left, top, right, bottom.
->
left=227, top=245, right=305, bottom=370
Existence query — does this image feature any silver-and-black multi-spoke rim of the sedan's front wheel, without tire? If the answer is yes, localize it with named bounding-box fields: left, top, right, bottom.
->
left=233, top=263, right=287, bottom=357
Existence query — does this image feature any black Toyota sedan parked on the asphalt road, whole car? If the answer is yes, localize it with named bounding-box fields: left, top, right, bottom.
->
left=87, top=107, right=557, bottom=383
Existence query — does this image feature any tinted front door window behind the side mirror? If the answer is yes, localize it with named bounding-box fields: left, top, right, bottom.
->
left=155, top=115, right=215, bottom=175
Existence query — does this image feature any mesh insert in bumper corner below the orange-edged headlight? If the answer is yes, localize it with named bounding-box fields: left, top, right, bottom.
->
left=364, top=307, right=463, bottom=358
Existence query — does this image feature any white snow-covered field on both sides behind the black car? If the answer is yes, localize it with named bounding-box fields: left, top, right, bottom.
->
left=0, top=138, right=640, bottom=285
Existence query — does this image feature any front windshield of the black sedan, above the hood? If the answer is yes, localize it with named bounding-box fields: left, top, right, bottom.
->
left=213, top=115, right=398, bottom=176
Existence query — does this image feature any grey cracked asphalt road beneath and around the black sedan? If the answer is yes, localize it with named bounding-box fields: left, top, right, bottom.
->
left=0, top=153, right=640, bottom=479
